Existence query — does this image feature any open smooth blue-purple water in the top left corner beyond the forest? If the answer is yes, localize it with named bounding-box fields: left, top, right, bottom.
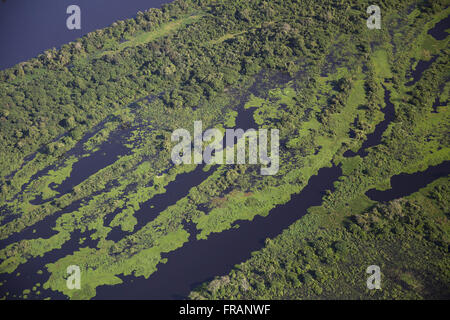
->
left=0, top=0, right=171, bottom=69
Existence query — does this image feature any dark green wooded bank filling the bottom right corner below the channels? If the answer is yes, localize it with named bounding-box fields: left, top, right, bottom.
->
left=191, top=178, right=450, bottom=299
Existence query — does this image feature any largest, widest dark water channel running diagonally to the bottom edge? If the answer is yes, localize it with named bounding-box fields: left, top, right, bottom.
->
left=96, top=167, right=342, bottom=299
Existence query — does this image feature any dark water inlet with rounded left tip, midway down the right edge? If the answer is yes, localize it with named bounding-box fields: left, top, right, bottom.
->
left=366, top=161, right=450, bottom=201
